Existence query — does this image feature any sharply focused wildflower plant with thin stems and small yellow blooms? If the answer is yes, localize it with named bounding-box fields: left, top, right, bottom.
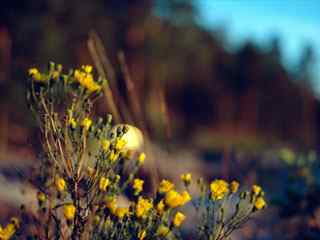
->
left=5, top=63, right=266, bottom=240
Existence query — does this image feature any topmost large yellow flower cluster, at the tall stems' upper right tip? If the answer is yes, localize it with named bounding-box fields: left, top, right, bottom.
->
left=74, top=66, right=101, bottom=92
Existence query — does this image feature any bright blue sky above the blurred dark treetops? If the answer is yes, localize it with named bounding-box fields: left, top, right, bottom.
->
left=194, top=0, right=320, bottom=92
